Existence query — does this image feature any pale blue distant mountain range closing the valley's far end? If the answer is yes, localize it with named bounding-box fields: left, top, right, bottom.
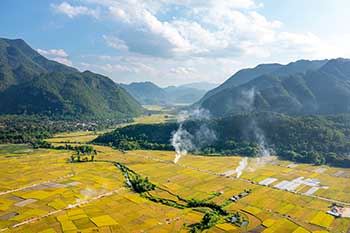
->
left=120, top=82, right=217, bottom=105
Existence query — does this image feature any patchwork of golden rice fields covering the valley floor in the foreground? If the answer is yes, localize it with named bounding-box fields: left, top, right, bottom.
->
left=0, top=133, right=350, bottom=233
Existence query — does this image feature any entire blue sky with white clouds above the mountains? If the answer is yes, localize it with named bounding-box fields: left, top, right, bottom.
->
left=0, top=0, right=350, bottom=86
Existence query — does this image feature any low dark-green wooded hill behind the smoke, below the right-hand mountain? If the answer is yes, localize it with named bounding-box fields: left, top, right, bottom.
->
left=94, top=112, right=350, bottom=167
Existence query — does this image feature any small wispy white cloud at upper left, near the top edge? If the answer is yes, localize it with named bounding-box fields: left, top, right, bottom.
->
left=51, top=2, right=100, bottom=18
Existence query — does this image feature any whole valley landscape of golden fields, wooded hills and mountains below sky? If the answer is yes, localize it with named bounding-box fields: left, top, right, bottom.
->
left=0, top=35, right=350, bottom=233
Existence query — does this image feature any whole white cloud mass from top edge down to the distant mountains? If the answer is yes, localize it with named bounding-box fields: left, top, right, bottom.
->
left=52, top=0, right=350, bottom=85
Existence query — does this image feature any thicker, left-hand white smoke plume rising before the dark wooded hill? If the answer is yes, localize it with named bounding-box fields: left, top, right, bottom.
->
left=171, top=109, right=216, bottom=163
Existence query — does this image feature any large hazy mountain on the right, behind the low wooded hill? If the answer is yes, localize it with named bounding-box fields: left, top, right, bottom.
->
left=200, top=59, right=350, bottom=116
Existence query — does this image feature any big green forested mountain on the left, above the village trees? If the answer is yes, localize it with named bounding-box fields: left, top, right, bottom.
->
left=0, top=39, right=143, bottom=118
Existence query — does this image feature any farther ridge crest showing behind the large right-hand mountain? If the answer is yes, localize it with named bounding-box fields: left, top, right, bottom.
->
left=199, top=60, right=327, bottom=103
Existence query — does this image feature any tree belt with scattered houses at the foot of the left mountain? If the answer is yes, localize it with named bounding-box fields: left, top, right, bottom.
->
left=0, top=115, right=131, bottom=143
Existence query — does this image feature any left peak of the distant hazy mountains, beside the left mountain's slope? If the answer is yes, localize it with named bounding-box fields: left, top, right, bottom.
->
left=121, top=82, right=168, bottom=105
